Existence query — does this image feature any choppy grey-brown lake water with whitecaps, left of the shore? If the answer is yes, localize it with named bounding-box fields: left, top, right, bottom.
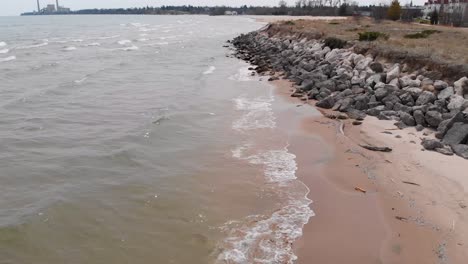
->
left=0, top=16, right=313, bottom=264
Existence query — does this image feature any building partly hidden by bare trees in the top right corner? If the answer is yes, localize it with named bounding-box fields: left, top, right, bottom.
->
left=423, top=0, right=468, bottom=27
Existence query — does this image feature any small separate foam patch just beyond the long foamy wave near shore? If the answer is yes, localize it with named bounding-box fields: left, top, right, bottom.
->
left=232, top=96, right=276, bottom=131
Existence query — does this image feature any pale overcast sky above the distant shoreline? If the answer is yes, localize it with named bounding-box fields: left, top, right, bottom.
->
left=0, top=0, right=424, bottom=16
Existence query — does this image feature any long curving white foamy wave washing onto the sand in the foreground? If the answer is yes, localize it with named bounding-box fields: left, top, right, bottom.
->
left=217, top=144, right=314, bottom=264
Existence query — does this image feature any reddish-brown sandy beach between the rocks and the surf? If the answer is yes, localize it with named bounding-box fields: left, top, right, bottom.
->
left=274, top=80, right=468, bottom=264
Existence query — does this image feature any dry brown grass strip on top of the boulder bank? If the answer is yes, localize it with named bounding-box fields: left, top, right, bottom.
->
left=272, top=18, right=468, bottom=64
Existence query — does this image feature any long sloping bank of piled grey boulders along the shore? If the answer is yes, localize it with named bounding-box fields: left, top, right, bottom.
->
left=231, top=27, right=468, bottom=159
